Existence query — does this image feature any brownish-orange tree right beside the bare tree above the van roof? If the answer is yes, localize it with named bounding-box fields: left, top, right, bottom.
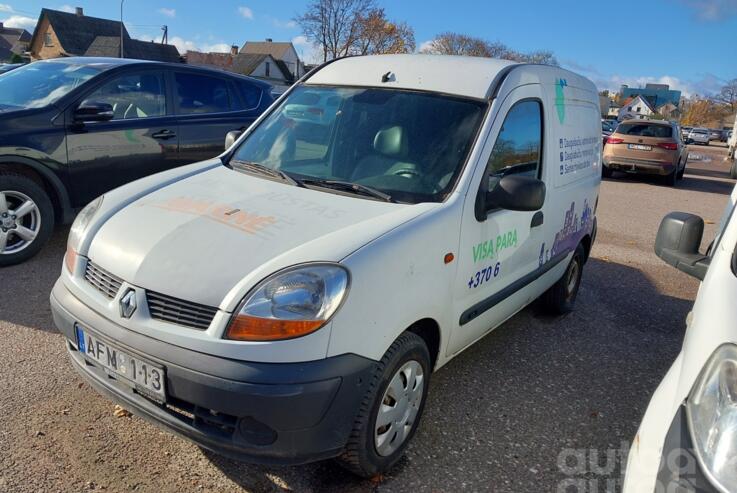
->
left=352, top=9, right=415, bottom=55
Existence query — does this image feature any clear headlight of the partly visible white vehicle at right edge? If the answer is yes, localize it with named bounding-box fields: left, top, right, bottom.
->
left=686, top=344, right=737, bottom=491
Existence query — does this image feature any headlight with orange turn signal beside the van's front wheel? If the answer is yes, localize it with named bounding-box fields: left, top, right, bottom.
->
left=225, top=263, right=350, bottom=341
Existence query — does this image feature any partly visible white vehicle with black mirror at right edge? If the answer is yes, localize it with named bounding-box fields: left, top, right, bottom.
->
left=624, top=184, right=737, bottom=493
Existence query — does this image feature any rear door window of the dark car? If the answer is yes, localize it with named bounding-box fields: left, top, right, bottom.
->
left=174, top=73, right=232, bottom=115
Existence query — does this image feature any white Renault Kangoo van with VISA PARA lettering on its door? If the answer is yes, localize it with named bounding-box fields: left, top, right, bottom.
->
left=51, top=55, right=601, bottom=476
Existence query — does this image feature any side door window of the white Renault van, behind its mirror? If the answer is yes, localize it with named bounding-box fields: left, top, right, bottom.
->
left=486, top=101, right=542, bottom=190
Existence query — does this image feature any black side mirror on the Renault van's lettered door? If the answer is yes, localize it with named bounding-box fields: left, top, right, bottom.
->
left=476, top=175, right=545, bottom=221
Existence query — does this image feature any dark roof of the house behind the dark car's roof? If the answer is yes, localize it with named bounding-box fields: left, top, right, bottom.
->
left=31, top=9, right=130, bottom=55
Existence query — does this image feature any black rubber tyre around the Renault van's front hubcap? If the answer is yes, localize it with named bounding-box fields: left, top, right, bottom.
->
left=337, top=332, right=432, bottom=478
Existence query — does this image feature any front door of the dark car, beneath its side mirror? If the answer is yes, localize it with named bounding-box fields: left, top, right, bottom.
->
left=66, top=68, right=179, bottom=206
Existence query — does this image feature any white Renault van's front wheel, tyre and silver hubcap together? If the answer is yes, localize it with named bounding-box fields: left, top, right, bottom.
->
left=338, top=332, right=432, bottom=478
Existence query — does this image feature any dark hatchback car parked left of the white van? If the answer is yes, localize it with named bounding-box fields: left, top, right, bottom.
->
left=0, top=58, right=273, bottom=266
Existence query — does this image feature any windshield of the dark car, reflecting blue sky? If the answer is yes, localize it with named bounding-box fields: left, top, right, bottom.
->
left=0, top=62, right=102, bottom=111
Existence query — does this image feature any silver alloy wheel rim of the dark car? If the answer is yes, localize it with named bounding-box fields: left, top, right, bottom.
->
left=0, top=190, right=41, bottom=255
